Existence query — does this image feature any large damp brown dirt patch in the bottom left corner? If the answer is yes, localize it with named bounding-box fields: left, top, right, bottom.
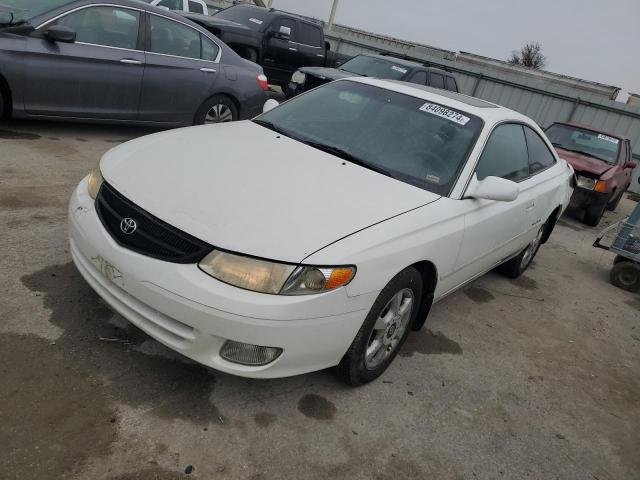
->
left=0, top=334, right=116, bottom=479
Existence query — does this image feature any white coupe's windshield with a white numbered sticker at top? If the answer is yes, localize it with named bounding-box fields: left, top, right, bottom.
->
left=254, top=80, right=482, bottom=195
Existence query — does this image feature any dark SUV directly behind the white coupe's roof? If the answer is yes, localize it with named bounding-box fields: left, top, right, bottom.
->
left=285, top=54, right=458, bottom=97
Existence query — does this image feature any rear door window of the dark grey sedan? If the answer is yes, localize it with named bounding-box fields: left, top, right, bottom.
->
left=149, top=15, right=200, bottom=60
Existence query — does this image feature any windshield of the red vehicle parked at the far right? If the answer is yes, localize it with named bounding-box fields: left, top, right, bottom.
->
left=545, top=123, right=620, bottom=163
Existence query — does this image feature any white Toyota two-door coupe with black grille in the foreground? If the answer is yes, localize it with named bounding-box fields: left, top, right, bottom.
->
left=69, top=78, right=573, bottom=385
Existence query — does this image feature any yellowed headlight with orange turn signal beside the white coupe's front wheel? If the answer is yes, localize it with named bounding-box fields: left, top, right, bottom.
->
left=199, top=250, right=355, bottom=295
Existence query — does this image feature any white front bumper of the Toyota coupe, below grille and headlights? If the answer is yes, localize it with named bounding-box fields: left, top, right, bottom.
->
left=69, top=179, right=376, bottom=378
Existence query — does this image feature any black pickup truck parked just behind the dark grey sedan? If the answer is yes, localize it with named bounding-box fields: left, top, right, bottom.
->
left=183, top=5, right=350, bottom=86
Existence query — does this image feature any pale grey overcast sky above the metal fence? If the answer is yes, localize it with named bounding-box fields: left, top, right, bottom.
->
left=272, top=0, right=640, bottom=101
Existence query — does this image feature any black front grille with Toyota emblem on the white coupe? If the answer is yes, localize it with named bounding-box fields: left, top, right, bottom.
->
left=96, top=182, right=213, bottom=263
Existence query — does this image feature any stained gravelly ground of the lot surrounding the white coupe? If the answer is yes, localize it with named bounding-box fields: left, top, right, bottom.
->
left=0, top=122, right=640, bottom=480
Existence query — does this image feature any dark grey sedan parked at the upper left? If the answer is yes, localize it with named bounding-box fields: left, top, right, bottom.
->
left=0, top=0, right=268, bottom=127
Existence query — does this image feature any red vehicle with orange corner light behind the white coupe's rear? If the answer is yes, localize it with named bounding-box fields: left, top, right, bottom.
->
left=545, top=122, right=636, bottom=226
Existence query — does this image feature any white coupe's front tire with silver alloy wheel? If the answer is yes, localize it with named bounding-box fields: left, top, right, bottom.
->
left=336, top=267, right=422, bottom=386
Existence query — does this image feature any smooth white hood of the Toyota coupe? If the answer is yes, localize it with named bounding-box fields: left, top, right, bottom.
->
left=100, top=121, right=440, bottom=262
